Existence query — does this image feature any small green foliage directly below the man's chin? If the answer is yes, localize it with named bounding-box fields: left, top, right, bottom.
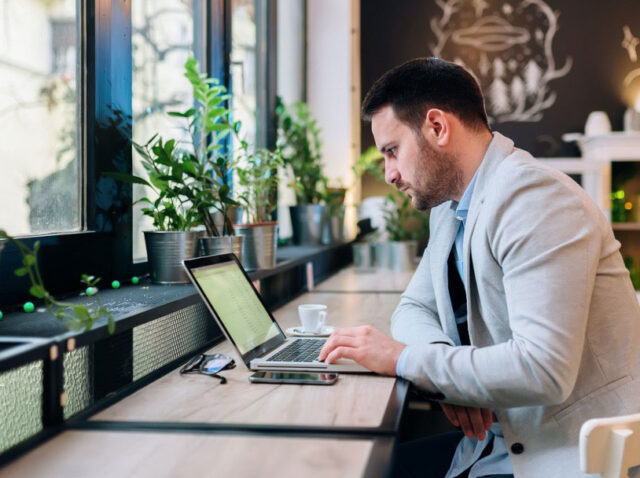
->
left=384, top=191, right=429, bottom=241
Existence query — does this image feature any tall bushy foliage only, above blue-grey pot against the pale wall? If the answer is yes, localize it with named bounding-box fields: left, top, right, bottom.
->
left=276, top=101, right=326, bottom=204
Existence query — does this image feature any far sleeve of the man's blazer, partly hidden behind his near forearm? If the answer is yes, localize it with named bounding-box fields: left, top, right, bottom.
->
left=391, top=231, right=454, bottom=345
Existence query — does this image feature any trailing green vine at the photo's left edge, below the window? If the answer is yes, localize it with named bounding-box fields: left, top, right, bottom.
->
left=0, top=229, right=115, bottom=334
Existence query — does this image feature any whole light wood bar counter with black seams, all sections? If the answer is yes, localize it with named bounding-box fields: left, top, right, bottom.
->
left=0, top=268, right=411, bottom=478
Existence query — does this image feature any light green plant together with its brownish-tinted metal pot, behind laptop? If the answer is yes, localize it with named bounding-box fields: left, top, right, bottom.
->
left=234, top=148, right=282, bottom=271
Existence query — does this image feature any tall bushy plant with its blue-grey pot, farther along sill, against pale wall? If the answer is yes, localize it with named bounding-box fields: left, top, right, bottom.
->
left=276, top=102, right=328, bottom=244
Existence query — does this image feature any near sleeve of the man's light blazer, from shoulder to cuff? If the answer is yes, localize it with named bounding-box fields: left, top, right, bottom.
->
left=403, top=167, right=604, bottom=408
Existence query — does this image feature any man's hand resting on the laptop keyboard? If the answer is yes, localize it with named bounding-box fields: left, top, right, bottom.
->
left=319, top=325, right=406, bottom=375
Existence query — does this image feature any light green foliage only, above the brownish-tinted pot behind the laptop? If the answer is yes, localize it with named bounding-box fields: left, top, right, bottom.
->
left=234, top=144, right=283, bottom=223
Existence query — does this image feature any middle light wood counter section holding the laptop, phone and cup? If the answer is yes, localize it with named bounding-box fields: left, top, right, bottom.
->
left=92, top=292, right=399, bottom=428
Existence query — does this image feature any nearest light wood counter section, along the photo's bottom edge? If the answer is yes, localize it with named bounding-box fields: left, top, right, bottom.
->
left=0, top=431, right=391, bottom=478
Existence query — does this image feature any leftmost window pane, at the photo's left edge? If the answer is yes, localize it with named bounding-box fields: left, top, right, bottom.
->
left=0, top=0, right=80, bottom=235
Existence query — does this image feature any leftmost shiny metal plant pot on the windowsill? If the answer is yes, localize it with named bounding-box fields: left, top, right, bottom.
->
left=144, top=231, right=203, bottom=284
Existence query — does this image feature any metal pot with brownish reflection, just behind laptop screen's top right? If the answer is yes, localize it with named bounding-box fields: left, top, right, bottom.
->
left=235, top=222, right=278, bottom=271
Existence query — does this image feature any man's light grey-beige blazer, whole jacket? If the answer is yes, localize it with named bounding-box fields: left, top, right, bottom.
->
left=391, top=133, right=640, bottom=478
